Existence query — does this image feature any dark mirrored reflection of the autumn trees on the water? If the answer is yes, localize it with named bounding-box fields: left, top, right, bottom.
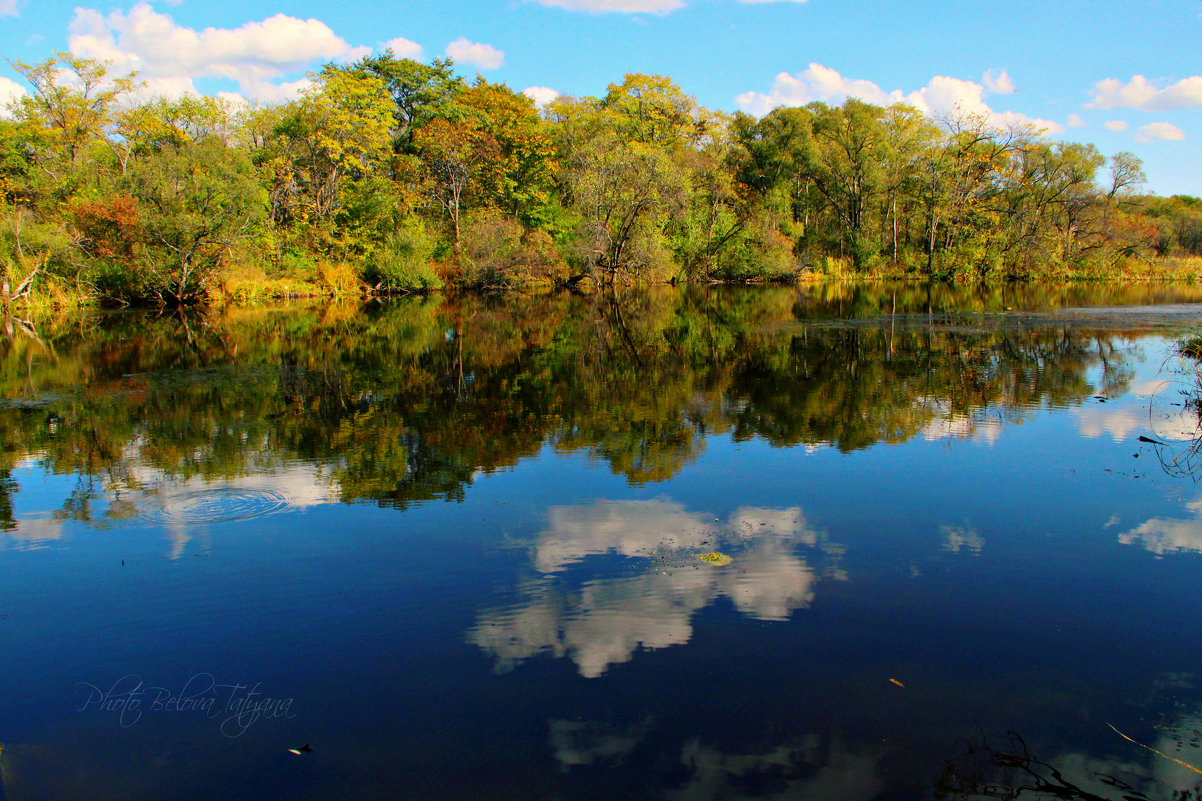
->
left=0, top=285, right=1182, bottom=520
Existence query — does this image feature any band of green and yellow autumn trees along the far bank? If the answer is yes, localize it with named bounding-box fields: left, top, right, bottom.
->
left=0, top=52, right=1202, bottom=305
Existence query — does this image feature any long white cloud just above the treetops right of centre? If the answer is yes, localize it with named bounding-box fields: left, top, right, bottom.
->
left=734, top=64, right=1064, bottom=134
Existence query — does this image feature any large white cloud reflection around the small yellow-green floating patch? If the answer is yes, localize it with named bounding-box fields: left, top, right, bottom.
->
left=468, top=499, right=819, bottom=678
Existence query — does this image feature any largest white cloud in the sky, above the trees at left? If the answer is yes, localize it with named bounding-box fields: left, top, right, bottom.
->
left=67, top=2, right=370, bottom=101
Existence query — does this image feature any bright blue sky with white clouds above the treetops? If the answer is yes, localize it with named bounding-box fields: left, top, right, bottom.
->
left=0, top=0, right=1202, bottom=196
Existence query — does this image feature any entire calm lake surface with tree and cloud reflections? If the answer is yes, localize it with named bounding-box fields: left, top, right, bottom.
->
left=0, top=286, right=1202, bottom=801
